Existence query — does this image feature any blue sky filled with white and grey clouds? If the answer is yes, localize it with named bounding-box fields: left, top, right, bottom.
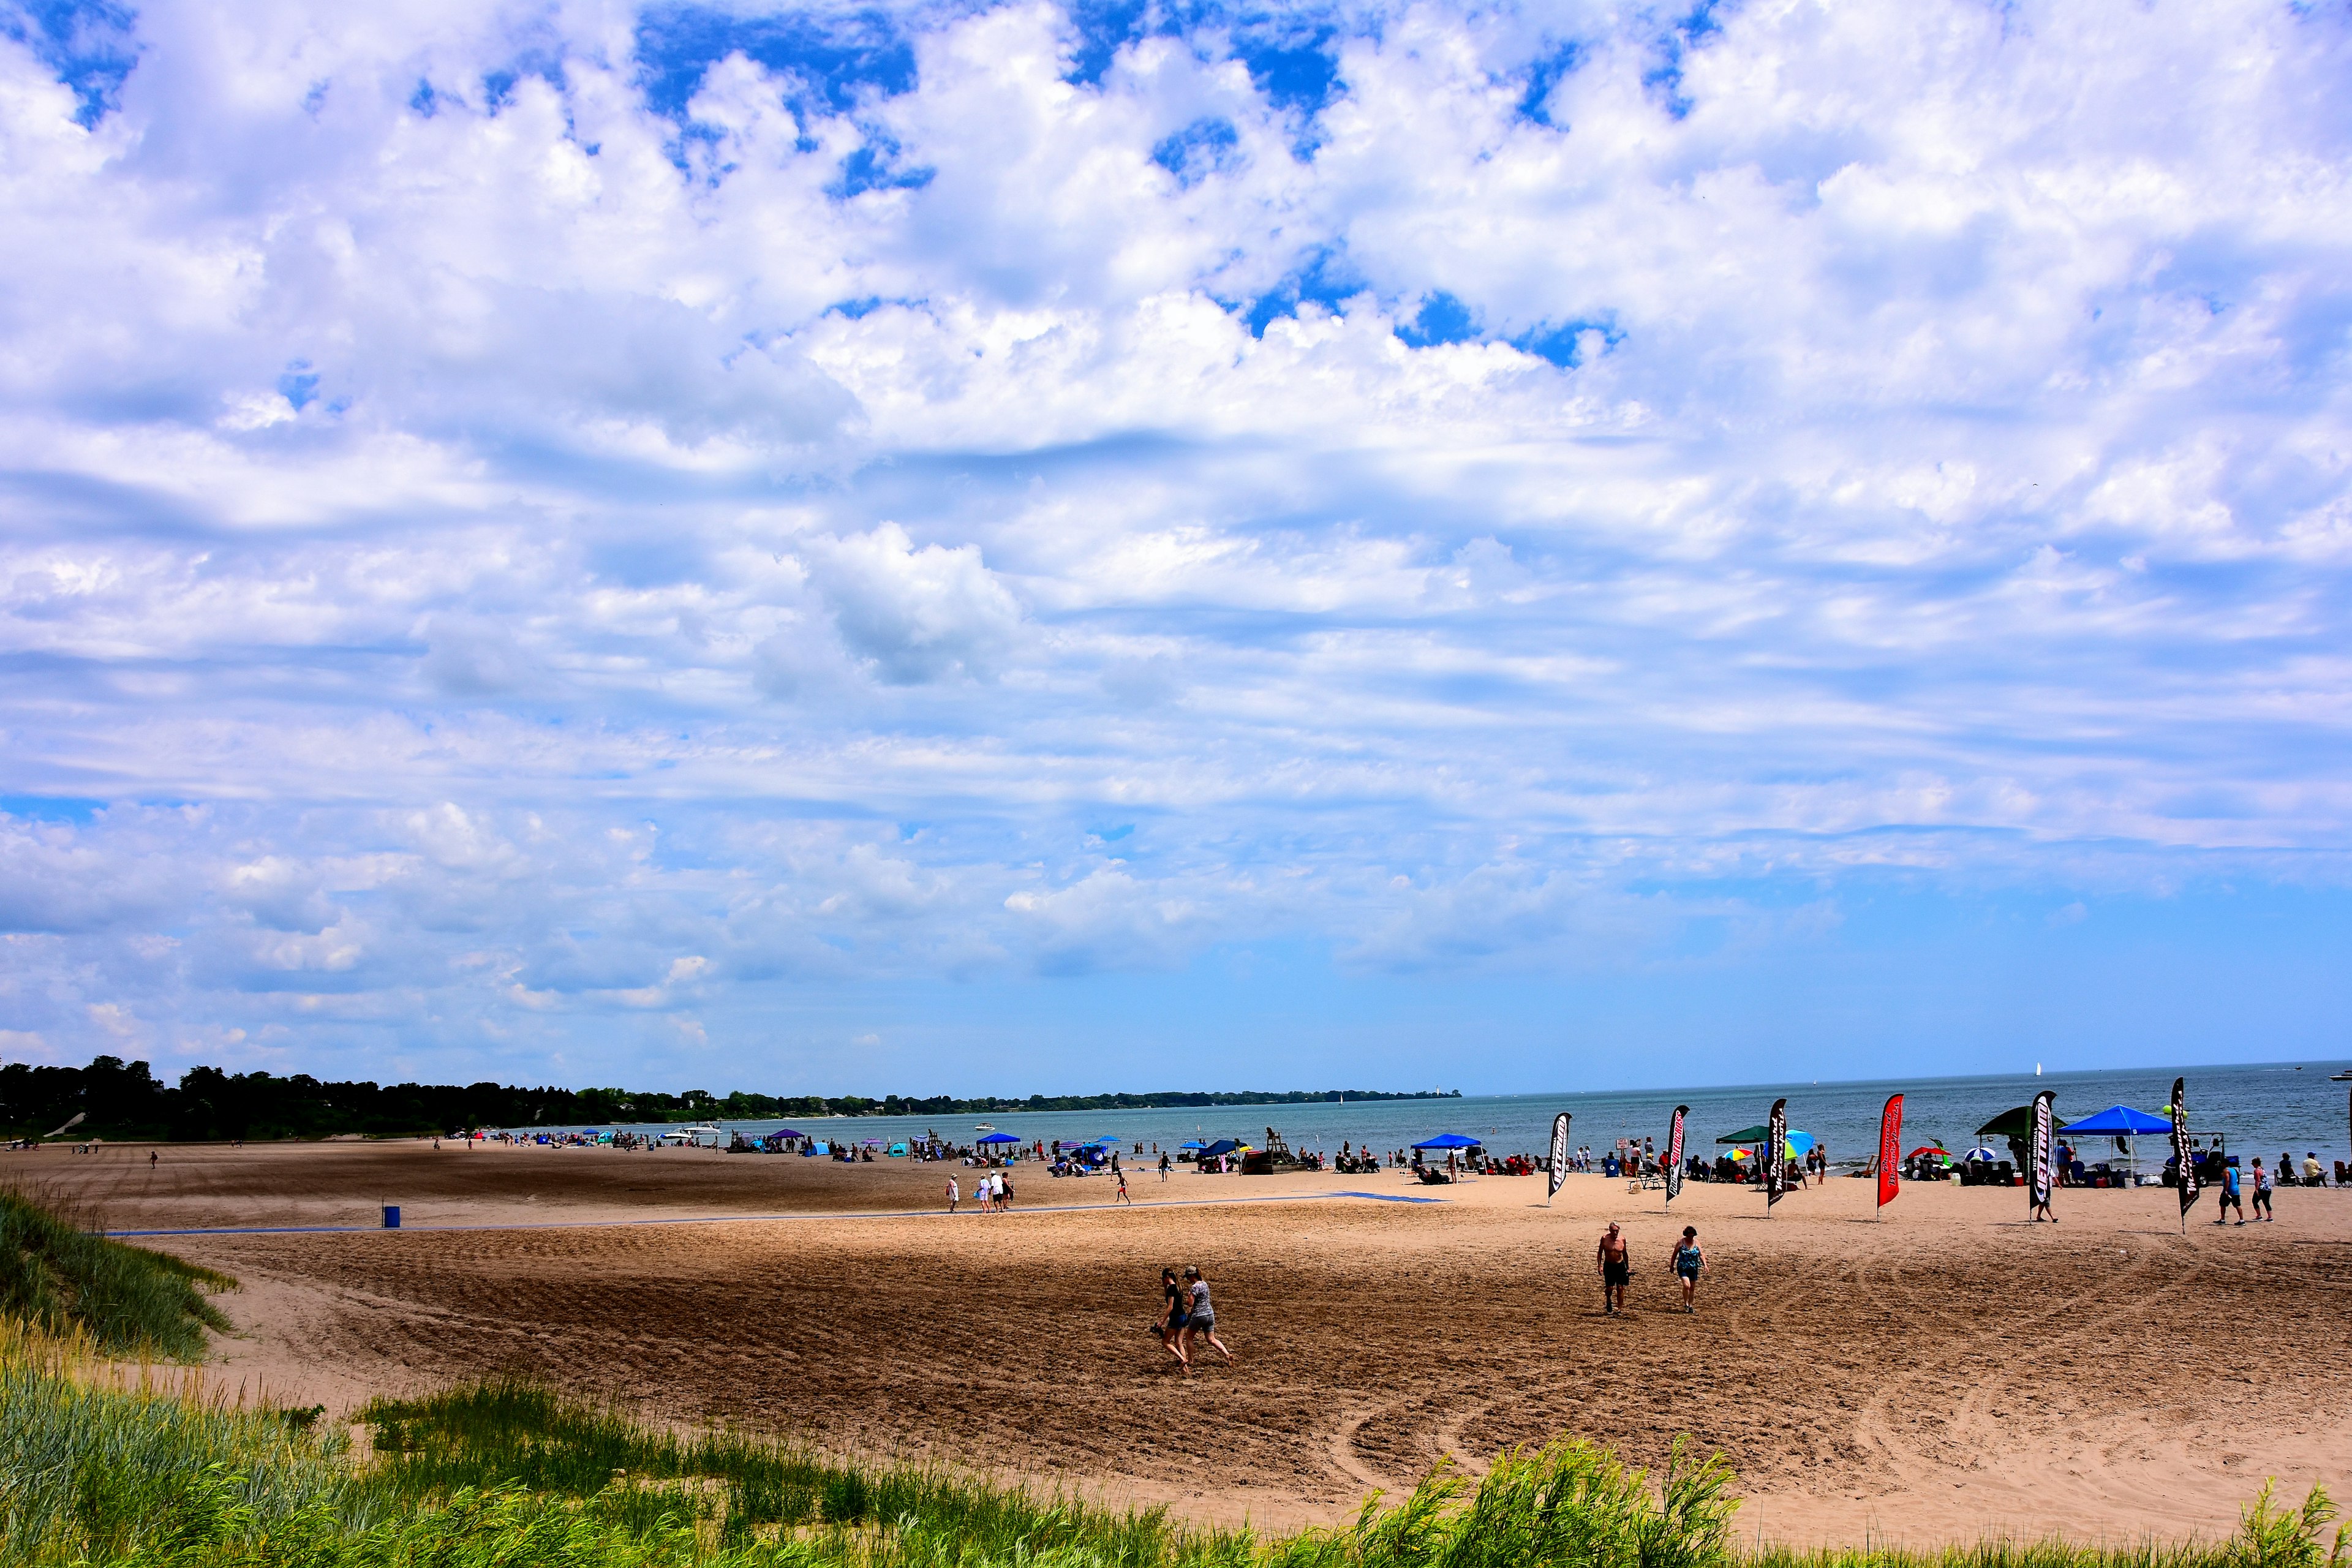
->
left=0, top=0, right=2352, bottom=1096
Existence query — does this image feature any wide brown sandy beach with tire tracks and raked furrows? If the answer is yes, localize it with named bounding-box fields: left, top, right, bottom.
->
left=0, top=1142, right=2352, bottom=1545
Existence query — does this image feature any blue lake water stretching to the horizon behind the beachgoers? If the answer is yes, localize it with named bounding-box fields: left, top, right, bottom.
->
left=500, top=1063, right=2352, bottom=1169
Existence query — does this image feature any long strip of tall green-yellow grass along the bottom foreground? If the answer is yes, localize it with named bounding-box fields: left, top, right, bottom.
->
left=0, top=1329, right=2352, bottom=1568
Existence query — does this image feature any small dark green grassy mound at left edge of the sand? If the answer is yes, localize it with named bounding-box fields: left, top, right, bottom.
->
left=0, top=1187, right=238, bottom=1361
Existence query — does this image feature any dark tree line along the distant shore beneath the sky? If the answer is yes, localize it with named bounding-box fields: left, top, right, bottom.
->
left=0, top=1055, right=1461, bottom=1142
